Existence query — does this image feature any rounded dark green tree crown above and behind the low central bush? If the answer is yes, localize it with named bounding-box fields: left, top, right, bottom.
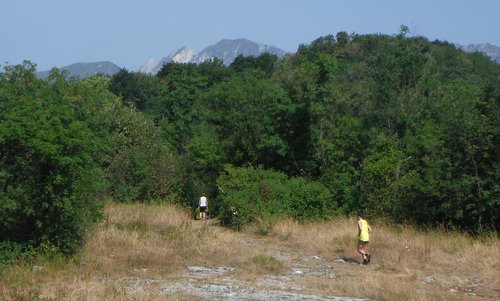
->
left=202, top=72, right=293, bottom=167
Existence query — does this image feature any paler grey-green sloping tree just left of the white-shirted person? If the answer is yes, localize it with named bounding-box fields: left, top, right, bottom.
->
left=106, top=106, right=182, bottom=201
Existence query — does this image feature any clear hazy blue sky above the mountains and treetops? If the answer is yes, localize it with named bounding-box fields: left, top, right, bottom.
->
left=0, top=0, right=500, bottom=71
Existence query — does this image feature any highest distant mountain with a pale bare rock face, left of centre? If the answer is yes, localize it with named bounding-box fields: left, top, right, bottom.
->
left=139, top=39, right=285, bottom=74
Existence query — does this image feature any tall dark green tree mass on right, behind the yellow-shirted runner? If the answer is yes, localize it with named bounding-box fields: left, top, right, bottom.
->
left=272, top=31, right=500, bottom=229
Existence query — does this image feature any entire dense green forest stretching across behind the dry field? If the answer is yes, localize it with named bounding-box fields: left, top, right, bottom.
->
left=0, top=26, right=500, bottom=261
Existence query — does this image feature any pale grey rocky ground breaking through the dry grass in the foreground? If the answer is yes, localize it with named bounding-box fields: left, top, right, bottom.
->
left=127, top=239, right=368, bottom=301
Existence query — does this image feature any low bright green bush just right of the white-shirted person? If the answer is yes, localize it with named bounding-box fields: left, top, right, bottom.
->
left=216, top=165, right=337, bottom=229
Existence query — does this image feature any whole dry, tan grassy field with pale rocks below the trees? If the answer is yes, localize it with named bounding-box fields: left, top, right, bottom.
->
left=0, top=204, right=500, bottom=300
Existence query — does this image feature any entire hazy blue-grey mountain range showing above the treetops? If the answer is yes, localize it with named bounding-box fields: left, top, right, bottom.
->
left=37, top=39, right=500, bottom=78
